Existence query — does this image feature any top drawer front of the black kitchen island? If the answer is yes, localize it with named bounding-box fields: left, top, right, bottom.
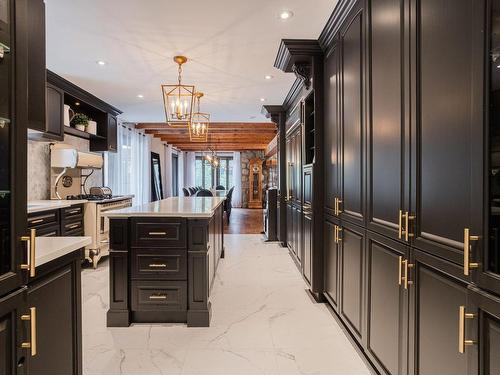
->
left=132, top=217, right=187, bottom=248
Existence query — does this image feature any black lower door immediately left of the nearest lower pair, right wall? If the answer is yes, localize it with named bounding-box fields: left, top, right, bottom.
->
left=340, top=223, right=364, bottom=341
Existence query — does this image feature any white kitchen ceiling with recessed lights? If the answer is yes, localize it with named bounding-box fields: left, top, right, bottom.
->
left=46, top=0, right=337, bottom=122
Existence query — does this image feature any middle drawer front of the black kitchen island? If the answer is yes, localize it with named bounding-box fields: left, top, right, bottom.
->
left=132, top=248, right=187, bottom=280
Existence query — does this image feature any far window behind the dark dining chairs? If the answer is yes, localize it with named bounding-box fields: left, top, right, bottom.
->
left=195, top=156, right=233, bottom=190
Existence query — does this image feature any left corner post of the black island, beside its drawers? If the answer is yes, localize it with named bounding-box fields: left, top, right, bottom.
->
left=107, top=218, right=130, bottom=327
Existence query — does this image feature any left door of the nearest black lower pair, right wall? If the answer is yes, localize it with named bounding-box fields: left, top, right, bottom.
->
left=365, top=231, right=409, bottom=375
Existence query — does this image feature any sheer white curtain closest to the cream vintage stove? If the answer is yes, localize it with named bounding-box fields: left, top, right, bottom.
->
left=105, top=125, right=151, bottom=205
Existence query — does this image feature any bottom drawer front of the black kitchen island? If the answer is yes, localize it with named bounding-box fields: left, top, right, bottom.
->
left=131, top=281, right=187, bottom=311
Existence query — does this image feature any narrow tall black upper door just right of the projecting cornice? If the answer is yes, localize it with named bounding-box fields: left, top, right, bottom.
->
left=324, top=41, right=340, bottom=214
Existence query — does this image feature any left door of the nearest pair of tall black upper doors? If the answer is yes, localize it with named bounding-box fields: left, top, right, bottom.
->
left=367, top=0, right=410, bottom=239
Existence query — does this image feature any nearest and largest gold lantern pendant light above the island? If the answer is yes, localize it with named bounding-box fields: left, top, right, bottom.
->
left=161, top=56, right=195, bottom=127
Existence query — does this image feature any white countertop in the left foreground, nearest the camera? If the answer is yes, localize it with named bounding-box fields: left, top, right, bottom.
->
left=35, top=237, right=92, bottom=267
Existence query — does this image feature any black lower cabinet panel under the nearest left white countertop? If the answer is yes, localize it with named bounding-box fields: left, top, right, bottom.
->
left=28, top=266, right=81, bottom=375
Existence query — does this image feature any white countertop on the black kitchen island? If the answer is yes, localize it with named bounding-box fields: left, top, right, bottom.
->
left=104, top=197, right=225, bottom=218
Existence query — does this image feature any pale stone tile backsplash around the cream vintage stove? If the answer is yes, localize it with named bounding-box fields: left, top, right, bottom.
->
left=28, top=135, right=103, bottom=201
